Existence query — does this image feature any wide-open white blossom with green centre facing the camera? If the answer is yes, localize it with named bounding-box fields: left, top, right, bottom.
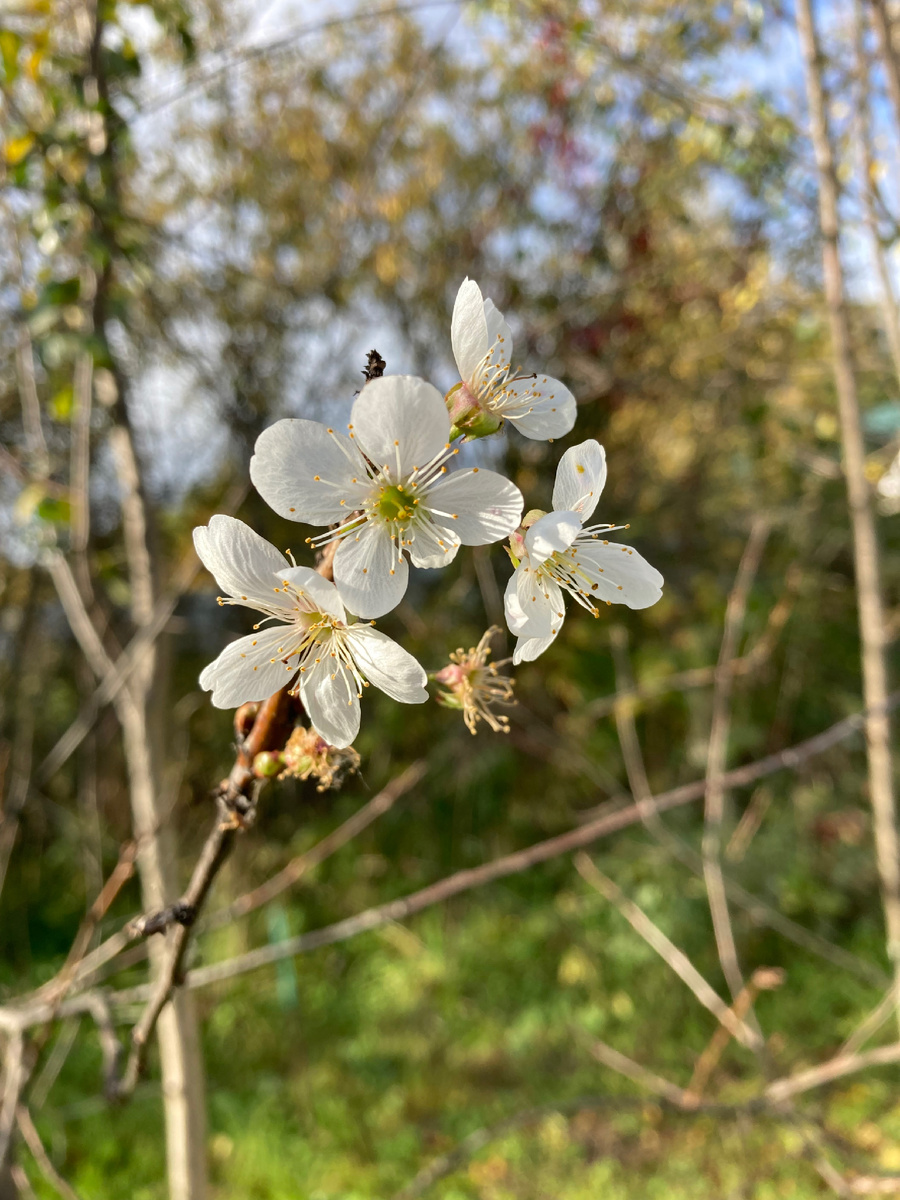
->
left=250, top=376, right=522, bottom=617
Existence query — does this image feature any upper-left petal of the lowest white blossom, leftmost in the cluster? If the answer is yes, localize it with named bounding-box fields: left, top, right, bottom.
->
left=193, top=514, right=288, bottom=607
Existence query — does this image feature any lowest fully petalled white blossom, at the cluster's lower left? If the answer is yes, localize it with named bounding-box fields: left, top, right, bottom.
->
left=193, top=515, right=428, bottom=746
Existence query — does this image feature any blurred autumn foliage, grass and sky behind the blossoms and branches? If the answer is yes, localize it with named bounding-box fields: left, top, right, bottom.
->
left=0, top=0, right=900, bottom=1200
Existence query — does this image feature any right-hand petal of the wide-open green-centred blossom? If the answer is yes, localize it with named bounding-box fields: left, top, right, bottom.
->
left=427, top=467, right=524, bottom=546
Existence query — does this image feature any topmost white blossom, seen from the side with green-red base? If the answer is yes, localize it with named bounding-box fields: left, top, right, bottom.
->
left=446, top=278, right=575, bottom=442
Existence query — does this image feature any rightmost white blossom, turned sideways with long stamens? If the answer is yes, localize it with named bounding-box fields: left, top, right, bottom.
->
left=505, top=439, right=662, bottom=664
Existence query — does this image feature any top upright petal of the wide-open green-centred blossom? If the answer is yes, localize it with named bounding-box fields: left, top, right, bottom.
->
left=350, top=376, right=450, bottom=481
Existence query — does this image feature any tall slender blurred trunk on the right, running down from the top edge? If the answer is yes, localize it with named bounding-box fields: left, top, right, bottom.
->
left=796, top=0, right=900, bottom=1020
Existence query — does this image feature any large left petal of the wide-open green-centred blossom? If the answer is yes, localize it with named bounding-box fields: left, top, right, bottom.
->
left=250, top=420, right=371, bottom=524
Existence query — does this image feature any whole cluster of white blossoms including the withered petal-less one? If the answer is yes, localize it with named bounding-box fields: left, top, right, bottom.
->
left=193, top=280, right=662, bottom=748
